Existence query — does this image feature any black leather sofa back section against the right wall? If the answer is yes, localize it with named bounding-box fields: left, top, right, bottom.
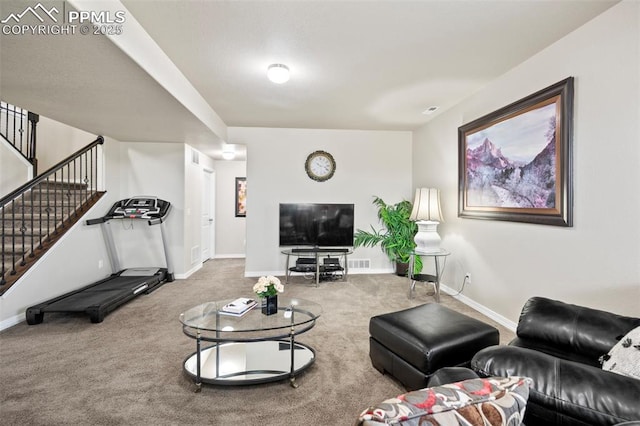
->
left=510, top=297, right=640, bottom=368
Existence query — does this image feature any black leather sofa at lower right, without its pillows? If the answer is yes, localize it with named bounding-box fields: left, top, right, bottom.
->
left=471, top=297, right=640, bottom=426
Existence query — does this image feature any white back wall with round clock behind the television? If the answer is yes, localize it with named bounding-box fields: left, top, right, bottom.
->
left=228, top=127, right=412, bottom=276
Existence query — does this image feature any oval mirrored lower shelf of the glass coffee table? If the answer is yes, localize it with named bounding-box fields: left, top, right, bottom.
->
left=184, top=340, right=316, bottom=385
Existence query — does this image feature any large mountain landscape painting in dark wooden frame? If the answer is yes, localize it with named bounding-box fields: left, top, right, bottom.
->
left=458, top=77, right=573, bottom=226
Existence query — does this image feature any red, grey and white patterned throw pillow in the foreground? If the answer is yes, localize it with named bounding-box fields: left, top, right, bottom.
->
left=356, top=376, right=531, bottom=426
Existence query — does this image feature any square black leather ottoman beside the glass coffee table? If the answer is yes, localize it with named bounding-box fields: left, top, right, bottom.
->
left=369, top=303, right=500, bottom=391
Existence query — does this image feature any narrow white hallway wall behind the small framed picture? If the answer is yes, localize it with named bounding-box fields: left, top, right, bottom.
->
left=214, top=160, right=247, bottom=258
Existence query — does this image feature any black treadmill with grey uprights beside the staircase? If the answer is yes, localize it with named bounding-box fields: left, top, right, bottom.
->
left=26, top=196, right=174, bottom=325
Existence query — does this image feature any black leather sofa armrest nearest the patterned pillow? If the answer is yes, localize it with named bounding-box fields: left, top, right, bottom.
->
left=471, top=346, right=640, bottom=425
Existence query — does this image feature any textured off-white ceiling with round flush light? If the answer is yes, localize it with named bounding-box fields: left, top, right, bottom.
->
left=0, top=0, right=617, bottom=158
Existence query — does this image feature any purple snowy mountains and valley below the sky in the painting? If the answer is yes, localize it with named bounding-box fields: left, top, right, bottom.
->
left=467, top=120, right=556, bottom=208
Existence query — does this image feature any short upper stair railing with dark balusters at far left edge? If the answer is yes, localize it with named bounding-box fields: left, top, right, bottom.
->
left=0, top=102, right=40, bottom=176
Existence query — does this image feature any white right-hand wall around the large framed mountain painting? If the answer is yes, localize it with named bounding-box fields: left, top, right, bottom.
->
left=413, top=1, right=640, bottom=323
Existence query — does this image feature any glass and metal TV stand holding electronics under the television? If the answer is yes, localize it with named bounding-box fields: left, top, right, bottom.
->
left=282, top=247, right=353, bottom=287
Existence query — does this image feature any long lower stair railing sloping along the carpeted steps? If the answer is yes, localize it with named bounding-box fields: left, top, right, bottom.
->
left=0, top=136, right=104, bottom=294
